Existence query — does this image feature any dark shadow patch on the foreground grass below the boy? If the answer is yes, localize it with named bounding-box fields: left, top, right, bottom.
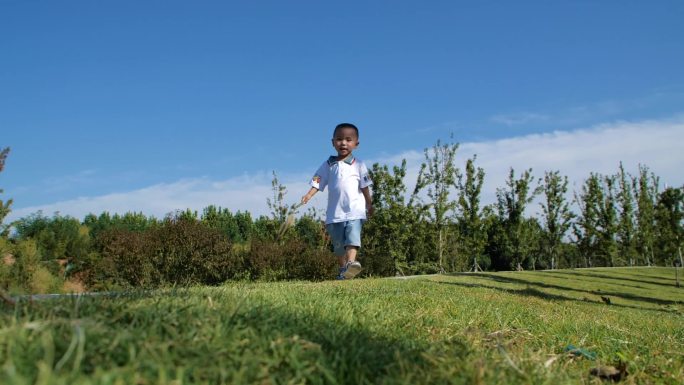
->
left=200, top=288, right=472, bottom=384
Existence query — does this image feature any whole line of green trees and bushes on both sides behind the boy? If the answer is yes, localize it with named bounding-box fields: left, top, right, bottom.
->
left=0, top=141, right=684, bottom=292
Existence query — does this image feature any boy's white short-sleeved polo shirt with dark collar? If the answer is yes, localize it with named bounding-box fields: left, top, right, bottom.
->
left=309, top=155, right=373, bottom=224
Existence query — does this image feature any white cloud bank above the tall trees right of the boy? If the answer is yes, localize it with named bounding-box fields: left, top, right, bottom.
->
left=374, top=118, right=684, bottom=213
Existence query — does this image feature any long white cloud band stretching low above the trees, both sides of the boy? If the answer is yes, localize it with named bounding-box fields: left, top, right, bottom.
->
left=8, top=118, right=684, bottom=220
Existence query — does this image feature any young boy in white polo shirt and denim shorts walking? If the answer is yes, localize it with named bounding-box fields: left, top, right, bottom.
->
left=302, top=123, right=373, bottom=279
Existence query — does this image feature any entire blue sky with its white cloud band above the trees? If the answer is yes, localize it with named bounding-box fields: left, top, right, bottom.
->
left=0, top=0, right=684, bottom=217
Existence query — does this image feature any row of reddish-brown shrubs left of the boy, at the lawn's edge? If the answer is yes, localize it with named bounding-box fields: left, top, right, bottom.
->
left=76, top=218, right=336, bottom=290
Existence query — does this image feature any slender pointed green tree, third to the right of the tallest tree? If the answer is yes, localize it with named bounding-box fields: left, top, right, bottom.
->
left=540, top=171, right=574, bottom=269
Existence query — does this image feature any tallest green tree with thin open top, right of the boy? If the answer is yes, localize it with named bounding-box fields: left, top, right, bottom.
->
left=411, top=140, right=459, bottom=272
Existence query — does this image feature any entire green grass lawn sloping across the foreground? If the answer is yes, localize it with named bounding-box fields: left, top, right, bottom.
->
left=0, top=268, right=684, bottom=384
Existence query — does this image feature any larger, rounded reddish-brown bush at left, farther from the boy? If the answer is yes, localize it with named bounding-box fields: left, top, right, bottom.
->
left=83, top=218, right=243, bottom=288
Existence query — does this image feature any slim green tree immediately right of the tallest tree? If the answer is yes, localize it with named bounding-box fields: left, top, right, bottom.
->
left=456, top=155, right=489, bottom=270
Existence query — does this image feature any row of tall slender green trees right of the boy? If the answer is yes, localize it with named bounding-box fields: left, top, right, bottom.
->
left=365, top=141, right=684, bottom=273
